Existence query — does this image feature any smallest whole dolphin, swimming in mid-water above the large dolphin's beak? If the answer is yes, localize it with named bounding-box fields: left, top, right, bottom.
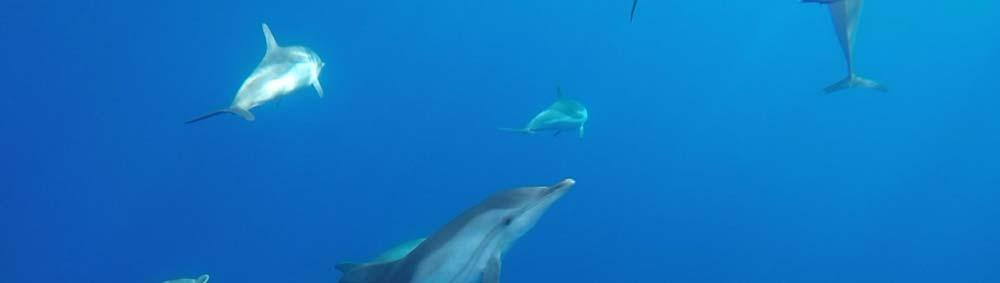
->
left=500, top=87, right=587, bottom=138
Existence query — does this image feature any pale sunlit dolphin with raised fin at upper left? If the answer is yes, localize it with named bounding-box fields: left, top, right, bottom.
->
left=187, top=24, right=325, bottom=124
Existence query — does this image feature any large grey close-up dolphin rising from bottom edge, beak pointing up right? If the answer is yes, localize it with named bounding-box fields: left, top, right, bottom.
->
left=337, top=179, right=575, bottom=283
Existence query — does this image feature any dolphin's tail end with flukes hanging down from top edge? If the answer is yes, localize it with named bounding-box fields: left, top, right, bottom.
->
left=802, top=0, right=889, bottom=93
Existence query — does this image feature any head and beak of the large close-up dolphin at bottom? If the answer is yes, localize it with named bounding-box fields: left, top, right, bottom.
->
left=483, top=179, right=576, bottom=250
